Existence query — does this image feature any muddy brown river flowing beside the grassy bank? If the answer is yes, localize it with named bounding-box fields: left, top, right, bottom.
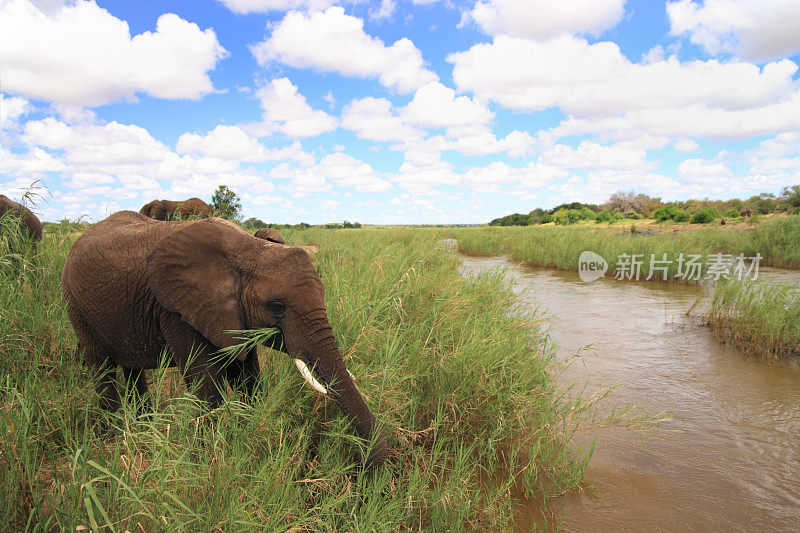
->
left=461, top=257, right=800, bottom=531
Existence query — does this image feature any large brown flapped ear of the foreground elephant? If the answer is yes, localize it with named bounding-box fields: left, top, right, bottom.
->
left=147, top=219, right=246, bottom=348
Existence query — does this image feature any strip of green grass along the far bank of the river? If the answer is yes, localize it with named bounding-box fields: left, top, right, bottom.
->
left=444, top=216, right=800, bottom=279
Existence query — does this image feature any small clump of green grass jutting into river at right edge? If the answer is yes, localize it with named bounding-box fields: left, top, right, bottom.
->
left=705, top=282, right=800, bottom=360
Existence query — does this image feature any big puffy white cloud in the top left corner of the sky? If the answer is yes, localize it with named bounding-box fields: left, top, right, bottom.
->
left=0, top=0, right=227, bottom=106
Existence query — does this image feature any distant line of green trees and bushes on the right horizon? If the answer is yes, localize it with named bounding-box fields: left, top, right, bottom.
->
left=489, top=185, right=800, bottom=226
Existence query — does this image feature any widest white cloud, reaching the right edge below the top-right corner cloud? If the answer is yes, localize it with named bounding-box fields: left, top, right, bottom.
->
left=448, top=36, right=800, bottom=143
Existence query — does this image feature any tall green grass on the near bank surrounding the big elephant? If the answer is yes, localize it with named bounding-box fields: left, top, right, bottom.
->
left=0, top=225, right=589, bottom=531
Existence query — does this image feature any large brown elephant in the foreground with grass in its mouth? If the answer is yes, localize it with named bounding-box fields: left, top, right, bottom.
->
left=61, top=211, right=387, bottom=466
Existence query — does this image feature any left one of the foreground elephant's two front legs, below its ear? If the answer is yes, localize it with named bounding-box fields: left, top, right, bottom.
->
left=161, top=313, right=225, bottom=408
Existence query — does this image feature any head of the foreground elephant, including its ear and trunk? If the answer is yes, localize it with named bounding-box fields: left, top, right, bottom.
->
left=147, top=218, right=387, bottom=466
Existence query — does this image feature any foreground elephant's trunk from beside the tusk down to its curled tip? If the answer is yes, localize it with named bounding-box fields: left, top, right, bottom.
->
left=312, top=335, right=388, bottom=468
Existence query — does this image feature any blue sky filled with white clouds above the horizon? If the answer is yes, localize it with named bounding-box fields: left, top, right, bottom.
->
left=0, top=0, right=800, bottom=224
